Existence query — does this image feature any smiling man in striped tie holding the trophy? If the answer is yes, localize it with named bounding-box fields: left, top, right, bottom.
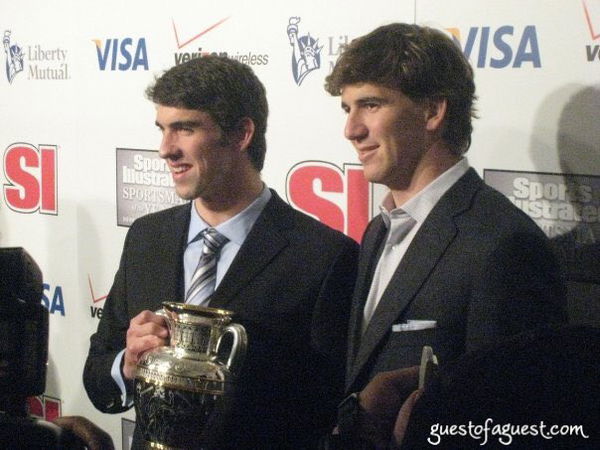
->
left=84, top=56, right=358, bottom=449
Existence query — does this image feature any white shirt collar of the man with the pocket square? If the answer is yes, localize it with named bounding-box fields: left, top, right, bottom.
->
left=379, top=157, right=469, bottom=228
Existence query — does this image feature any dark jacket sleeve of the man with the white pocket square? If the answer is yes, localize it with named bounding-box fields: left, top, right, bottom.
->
left=466, top=232, right=567, bottom=351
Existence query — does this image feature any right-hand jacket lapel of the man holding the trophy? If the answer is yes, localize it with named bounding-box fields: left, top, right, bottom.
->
left=210, top=191, right=289, bottom=309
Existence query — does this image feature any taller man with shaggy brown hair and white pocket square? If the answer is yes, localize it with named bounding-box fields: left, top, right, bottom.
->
left=326, top=24, right=566, bottom=446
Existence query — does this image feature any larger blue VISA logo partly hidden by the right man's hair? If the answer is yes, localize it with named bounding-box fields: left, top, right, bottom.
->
left=446, top=25, right=542, bottom=69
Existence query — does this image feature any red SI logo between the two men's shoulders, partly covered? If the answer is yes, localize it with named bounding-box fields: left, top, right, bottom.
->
left=286, top=161, right=373, bottom=242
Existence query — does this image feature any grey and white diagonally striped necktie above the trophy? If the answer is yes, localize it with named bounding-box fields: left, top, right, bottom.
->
left=185, top=228, right=229, bottom=304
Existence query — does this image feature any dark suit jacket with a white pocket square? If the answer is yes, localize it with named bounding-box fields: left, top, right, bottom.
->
left=346, top=169, right=566, bottom=392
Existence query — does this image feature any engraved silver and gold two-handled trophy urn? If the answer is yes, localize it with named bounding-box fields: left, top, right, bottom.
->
left=134, top=302, right=247, bottom=449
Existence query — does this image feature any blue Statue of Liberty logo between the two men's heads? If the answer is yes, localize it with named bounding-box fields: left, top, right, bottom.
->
left=287, top=17, right=323, bottom=86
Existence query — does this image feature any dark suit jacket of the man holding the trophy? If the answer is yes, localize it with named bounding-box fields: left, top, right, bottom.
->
left=84, top=191, right=358, bottom=448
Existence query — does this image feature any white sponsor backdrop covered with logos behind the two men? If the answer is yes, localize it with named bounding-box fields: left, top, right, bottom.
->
left=0, top=0, right=600, bottom=449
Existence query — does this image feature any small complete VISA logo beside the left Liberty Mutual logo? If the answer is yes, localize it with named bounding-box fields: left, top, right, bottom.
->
left=92, top=37, right=148, bottom=71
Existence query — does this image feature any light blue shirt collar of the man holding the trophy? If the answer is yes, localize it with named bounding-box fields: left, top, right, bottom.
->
left=187, top=184, right=271, bottom=246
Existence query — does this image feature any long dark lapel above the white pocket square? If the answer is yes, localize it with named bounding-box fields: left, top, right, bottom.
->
left=347, top=169, right=483, bottom=386
